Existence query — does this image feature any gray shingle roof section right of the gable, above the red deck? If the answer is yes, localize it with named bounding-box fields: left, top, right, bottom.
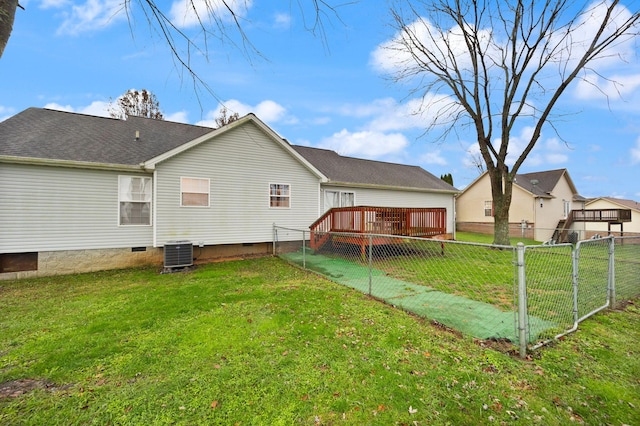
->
left=293, top=145, right=459, bottom=192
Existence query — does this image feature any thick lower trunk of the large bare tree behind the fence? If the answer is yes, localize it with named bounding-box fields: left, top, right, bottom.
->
left=489, top=167, right=513, bottom=246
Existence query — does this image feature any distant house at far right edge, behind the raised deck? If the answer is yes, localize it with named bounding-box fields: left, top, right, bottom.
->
left=585, top=197, right=640, bottom=238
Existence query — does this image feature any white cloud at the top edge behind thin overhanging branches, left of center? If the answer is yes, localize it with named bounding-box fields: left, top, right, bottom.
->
left=169, top=0, right=253, bottom=28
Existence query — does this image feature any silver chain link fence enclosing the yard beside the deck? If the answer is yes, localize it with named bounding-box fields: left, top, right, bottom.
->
left=273, top=226, right=640, bottom=356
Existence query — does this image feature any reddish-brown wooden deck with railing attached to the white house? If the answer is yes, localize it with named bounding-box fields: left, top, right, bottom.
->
left=310, top=206, right=447, bottom=250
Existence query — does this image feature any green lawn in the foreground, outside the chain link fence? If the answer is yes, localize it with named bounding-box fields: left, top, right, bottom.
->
left=0, top=258, right=640, bottom=425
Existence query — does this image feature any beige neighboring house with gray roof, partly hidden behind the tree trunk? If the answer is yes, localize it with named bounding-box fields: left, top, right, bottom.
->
left=456, top=169, right=585, bottom=241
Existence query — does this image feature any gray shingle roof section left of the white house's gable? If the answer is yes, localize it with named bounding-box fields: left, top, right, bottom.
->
left=0, top=108, right=213, bottom=165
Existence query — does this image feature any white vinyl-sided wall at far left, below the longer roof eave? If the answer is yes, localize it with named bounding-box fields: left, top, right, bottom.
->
left=0, top=163, right=153, bottom=253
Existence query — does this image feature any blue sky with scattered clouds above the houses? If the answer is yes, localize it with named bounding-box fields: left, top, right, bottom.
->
left=0, top=0, right=640, bottom=200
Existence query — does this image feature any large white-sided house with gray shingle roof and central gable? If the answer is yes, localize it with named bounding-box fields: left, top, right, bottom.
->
left=0, top=108, right=457, bottom=279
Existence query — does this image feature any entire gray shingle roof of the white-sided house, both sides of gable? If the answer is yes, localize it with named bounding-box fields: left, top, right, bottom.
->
left=0, top=108, right=458, bottom=192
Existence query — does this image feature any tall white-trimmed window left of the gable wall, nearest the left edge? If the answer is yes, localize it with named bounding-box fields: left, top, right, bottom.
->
left=118, top=176, right=152, bottom=225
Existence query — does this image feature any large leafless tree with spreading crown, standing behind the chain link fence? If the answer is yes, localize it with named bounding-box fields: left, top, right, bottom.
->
left=385, top=0, right=640, bottom=244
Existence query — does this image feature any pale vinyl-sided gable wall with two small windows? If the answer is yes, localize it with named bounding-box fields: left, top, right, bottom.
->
left=154, top=122, right=319, bottom=246
